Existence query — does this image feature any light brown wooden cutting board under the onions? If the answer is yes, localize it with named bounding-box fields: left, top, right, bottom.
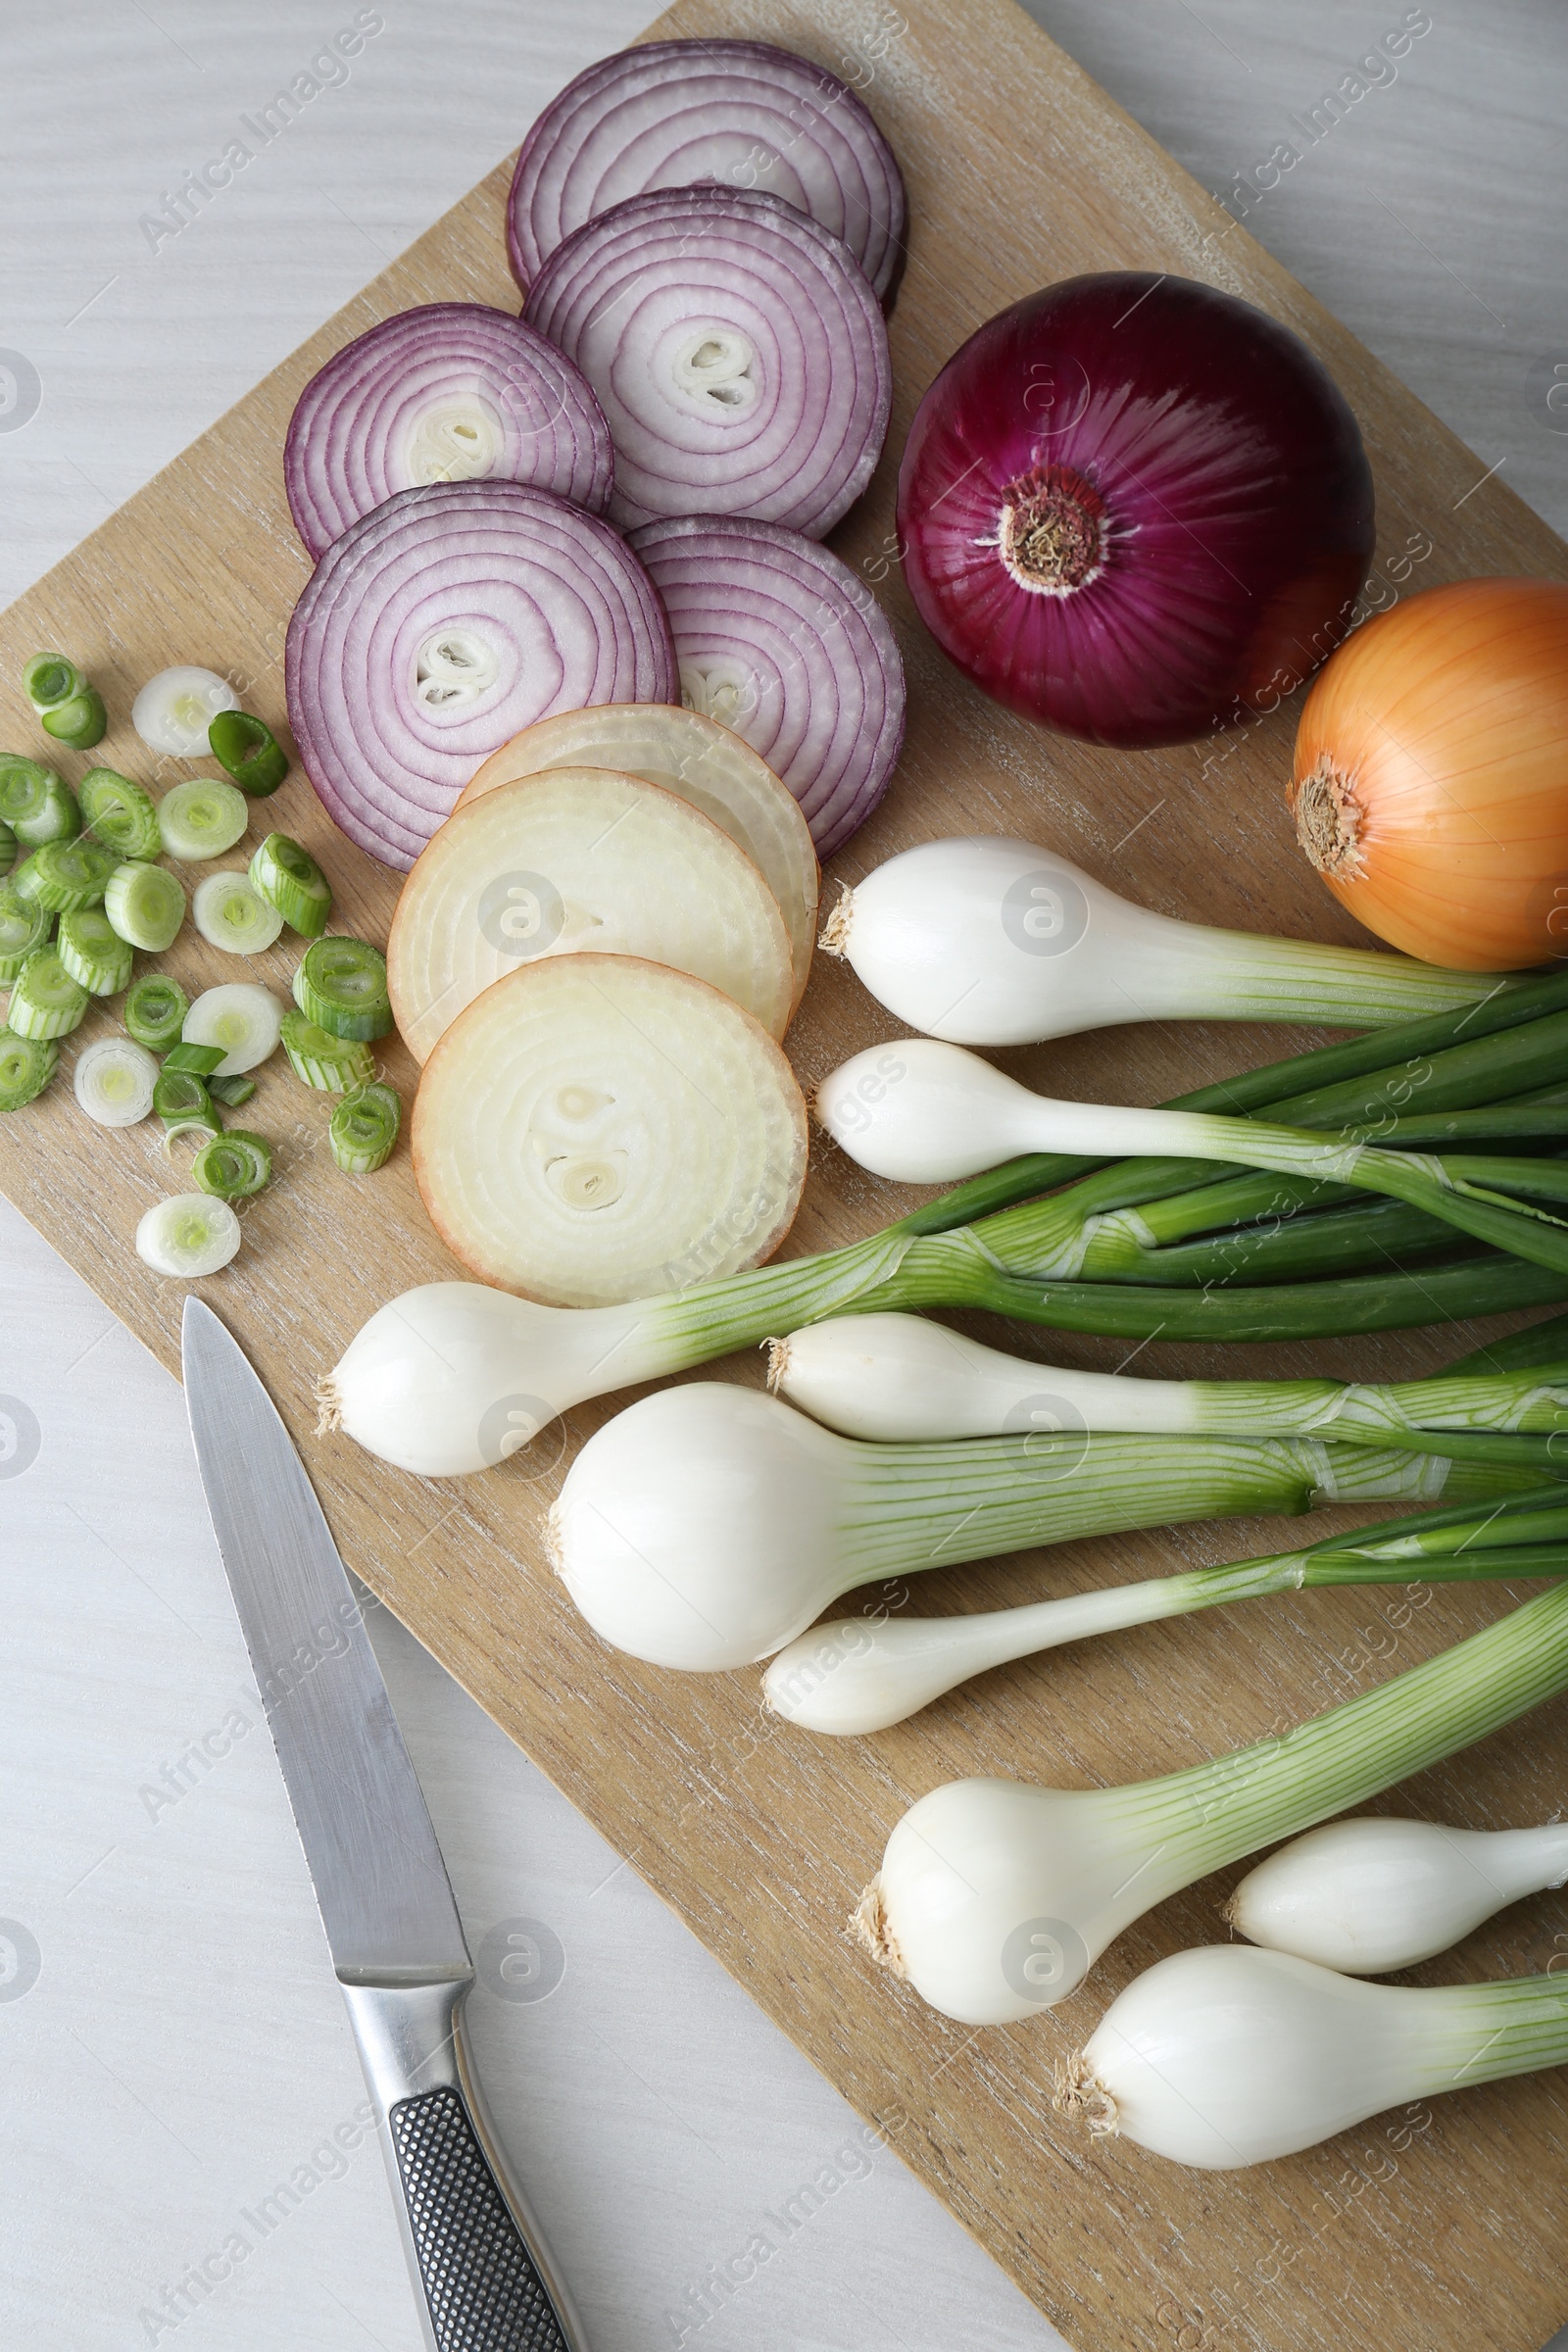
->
left=0, top=0, right=1568, bottom=2352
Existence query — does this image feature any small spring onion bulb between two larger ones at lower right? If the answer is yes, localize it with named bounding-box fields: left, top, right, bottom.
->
left=1225, top=1816, right=1568, bottom=1976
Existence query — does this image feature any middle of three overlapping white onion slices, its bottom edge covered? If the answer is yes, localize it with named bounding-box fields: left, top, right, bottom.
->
left=385, top=766, right=795, bottom=1060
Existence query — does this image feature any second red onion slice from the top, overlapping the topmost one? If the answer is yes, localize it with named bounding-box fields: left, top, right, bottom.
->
left=524, top=188, right=891, bottom=539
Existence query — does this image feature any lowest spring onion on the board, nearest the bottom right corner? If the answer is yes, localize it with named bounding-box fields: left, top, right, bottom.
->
left=1055, top=1942, right=1568, bottom=2171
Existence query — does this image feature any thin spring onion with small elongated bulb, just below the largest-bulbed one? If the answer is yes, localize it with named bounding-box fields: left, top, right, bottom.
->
left=761, top=1495, right=1568, bottom=1740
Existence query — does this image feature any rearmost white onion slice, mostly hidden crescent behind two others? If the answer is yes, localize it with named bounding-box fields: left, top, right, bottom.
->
left=459, top=704, right=820, bottom=1004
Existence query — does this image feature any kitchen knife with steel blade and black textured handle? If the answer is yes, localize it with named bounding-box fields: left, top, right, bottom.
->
left=183, top=1298, right=583, bottom=2352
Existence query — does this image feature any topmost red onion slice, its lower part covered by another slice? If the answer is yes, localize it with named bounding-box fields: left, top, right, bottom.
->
left=506, top=40, right=906, bottom=301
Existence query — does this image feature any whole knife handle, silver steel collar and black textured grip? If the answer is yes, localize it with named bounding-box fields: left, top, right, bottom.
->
left=343, top=1978, right=583, bottom=2352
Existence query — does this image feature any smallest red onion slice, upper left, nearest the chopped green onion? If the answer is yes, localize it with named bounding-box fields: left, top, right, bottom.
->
left=282, top=301, right=613, bottom=555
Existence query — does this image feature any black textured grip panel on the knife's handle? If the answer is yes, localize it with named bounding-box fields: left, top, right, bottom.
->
left=388, top=2086, right=569, bottom=2352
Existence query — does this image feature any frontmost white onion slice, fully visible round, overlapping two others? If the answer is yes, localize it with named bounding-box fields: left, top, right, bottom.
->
left=414, top=955, right=807, bottom=1307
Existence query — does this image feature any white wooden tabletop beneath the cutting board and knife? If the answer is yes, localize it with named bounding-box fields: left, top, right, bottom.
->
left=0, top=0, right=1568, bottom=2352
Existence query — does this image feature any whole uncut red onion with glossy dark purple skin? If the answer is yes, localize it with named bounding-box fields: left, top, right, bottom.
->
left=898, top=270, right=1373, bottom=751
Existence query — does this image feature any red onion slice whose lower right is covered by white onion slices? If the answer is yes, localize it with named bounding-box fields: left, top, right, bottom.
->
left=287, top=482, right=677, bottom=870
